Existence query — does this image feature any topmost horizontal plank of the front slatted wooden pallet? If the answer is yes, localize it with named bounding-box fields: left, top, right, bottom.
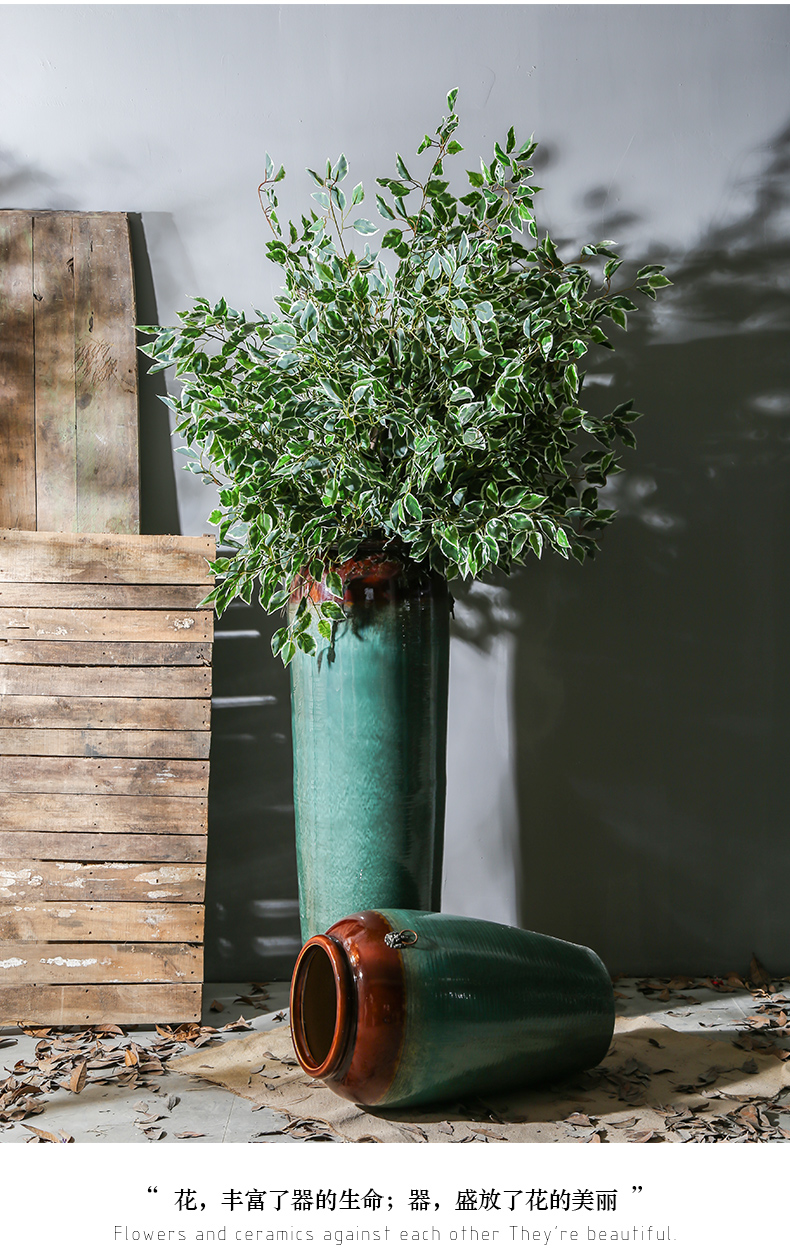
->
left=0, top=530, right=216, bottom=584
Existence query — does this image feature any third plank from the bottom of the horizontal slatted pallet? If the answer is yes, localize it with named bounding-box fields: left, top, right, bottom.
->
left=0, top=901, right=206, bottom=944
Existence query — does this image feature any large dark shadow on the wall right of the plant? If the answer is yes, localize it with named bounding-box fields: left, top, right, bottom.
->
left=506, top=117, right=790, bottom=975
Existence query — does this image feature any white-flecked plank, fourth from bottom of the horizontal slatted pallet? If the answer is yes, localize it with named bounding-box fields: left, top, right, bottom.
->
left=0, top=858, right=206, bottom=905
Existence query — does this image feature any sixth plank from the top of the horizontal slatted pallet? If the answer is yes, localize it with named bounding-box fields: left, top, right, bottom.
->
left=0, top=697, right=211, bottom=730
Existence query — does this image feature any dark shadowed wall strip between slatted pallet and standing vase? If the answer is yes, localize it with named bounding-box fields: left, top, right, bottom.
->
left=206, top=576, right=301, bottom=982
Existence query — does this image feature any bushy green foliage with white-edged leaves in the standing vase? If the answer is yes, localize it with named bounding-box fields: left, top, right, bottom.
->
left=140, top=91, right=670, bottom=664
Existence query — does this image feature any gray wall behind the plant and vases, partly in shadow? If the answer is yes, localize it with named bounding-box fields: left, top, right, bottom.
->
left=6, top=5, right=790, bottom=979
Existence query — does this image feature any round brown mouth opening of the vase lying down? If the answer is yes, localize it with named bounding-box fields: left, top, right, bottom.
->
left=291, top=936, right=351, bottom=1079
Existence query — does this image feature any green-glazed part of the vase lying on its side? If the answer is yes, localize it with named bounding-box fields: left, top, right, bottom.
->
left=379, top=908, right=614, bottom=1106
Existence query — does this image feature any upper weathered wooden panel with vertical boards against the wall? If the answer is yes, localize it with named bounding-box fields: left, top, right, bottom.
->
left=0, top=209, right=139, bottom=533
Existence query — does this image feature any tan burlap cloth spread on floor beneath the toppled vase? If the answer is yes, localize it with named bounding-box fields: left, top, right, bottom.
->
left=168, top=1016, right=790, bottom=1144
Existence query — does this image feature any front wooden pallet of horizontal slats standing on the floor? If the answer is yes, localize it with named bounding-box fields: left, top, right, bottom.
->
left=0, top=530, right=214, bottom=1025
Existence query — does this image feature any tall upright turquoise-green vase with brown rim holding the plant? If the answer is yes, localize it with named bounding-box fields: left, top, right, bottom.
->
left=290, top=551, right=450, bottom=940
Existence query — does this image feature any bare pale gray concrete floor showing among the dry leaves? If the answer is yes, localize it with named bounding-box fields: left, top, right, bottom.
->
left=0, top=979, right=790, bottom=1144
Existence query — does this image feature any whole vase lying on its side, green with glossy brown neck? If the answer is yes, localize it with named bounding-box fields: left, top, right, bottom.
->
left=291, top=908, right=614, bottom=1106
